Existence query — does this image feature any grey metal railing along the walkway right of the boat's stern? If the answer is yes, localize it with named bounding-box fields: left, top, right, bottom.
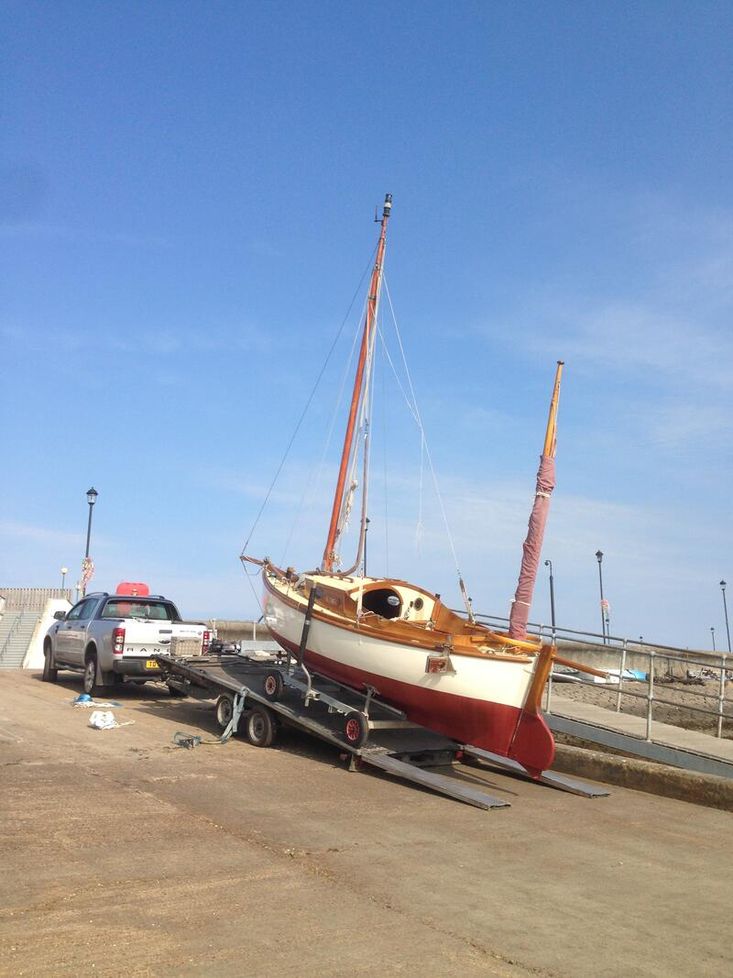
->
left=466, top=614, right=733, bottom=741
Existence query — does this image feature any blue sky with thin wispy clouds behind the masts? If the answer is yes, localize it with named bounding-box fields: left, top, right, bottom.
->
left=0, top=0, right=733, bottom=648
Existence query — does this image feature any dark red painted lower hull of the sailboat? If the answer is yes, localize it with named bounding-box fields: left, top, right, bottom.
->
left=274, top=635, right=555, bottom=777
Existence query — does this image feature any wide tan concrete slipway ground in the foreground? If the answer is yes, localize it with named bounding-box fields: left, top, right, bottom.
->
left=0, top=672, right=733, bottom=978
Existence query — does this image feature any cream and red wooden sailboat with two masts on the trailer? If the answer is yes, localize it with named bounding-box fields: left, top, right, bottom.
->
left=241, top=194, right=562, bottom=777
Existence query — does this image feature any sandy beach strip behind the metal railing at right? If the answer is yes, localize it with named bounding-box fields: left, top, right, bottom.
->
left=543, top=679, right=733, bottom=738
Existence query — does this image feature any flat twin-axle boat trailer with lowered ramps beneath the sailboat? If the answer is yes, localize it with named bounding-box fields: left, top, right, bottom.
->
left=156, top=651, right=608, bottom=809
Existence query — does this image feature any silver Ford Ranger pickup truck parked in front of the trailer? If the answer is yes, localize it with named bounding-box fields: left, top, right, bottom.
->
left=43, top=588, right=213, bottom=696
